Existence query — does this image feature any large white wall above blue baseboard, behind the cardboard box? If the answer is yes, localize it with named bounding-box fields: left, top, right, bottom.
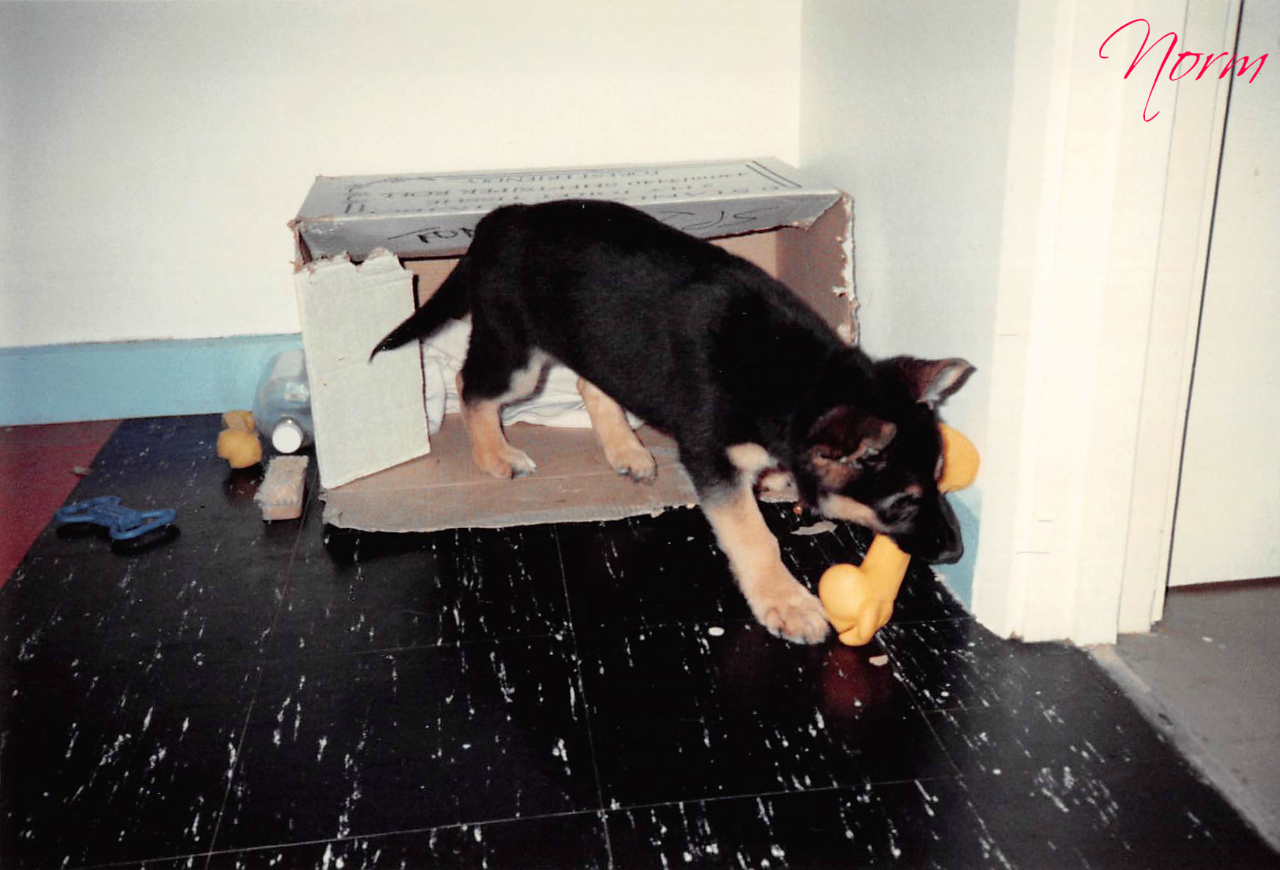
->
left=0, top=0, right=800, bottom=347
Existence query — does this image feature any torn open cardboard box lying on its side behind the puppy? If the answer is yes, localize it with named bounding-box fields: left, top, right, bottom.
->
left=291, top=159, right=858, bottom=531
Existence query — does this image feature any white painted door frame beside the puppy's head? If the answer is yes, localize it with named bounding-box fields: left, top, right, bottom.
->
left=973, top=0, right=1240, bottom=644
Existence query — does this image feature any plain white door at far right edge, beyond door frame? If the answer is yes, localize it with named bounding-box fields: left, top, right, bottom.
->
left=1169, top=0, right=1280, bottom=586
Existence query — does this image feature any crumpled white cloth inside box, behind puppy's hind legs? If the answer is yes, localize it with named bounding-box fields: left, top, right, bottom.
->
left=422, top=320, right=640, bottom=435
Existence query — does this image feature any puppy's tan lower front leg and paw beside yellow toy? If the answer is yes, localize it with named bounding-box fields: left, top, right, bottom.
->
left=703, top=479, right=828, bottom=644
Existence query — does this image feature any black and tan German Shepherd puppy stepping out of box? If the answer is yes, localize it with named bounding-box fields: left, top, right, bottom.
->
left=370, top=200, right=974, bottom=644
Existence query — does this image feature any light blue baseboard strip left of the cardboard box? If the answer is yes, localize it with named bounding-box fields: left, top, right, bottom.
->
left=0, top=334, right=302, bottom=426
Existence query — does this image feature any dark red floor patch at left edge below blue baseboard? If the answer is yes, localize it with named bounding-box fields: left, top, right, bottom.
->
left=0, top=420, right=119, bottom=587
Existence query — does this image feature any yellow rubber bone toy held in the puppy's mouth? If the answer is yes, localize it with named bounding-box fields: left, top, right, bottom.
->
left=818, top=423, right=978, bottom=646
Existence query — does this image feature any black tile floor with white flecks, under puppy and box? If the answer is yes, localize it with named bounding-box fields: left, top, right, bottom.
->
left=0, top=417, right=1280, bottom=870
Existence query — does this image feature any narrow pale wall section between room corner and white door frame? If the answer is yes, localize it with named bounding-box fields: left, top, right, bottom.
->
left=800, top=0, right=1018, bottom=448
